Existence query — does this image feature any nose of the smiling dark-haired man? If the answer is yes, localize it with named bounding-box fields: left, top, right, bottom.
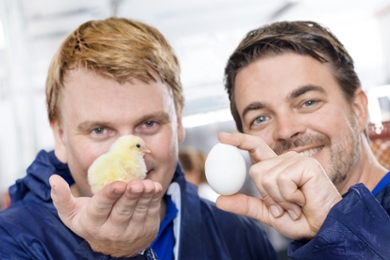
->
left=274, top=113, right=306, bottom=141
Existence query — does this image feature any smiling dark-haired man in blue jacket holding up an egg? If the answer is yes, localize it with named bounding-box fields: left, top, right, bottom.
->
left=217, top=21, right=390, bottom=259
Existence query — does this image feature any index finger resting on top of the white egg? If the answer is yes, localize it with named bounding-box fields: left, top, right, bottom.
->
left=218, top=132, right=277, bottom=162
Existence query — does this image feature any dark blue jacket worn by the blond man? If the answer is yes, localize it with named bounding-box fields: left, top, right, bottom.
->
left=0, top=151, right=277, bottom=260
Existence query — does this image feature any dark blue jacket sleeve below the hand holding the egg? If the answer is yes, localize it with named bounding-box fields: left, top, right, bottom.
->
left=288, top=184, right=390, bottom=260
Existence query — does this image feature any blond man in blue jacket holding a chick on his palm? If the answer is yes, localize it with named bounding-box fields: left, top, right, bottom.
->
left=0, top=18, right=276, bottom=260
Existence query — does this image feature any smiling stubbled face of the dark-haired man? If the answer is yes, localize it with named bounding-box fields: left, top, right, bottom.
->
left=235, top=53, right=367, bottom=192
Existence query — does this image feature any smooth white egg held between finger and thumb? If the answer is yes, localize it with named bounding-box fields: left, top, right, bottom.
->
left=205, top=143, right=246, bottom=195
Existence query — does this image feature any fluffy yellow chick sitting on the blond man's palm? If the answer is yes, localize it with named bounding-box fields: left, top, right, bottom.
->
left=88, top=135, right=150, bottom=194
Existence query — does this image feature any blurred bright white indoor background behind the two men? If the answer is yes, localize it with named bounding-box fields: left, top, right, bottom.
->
left=0, top=0, right=390, bottom=256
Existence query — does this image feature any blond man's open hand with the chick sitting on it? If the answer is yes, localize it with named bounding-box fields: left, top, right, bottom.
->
left=50, top=175, right=163, bottom=257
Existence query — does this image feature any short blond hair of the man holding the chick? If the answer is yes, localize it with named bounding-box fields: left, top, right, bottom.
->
left=46, top=17, right=184, bottom=122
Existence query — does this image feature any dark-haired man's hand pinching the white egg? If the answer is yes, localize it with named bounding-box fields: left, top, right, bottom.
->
left=217, top=133, right=341, bottom=240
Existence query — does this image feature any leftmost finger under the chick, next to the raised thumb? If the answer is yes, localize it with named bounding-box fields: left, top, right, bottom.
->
left=87, top=181, right=126, bottom=226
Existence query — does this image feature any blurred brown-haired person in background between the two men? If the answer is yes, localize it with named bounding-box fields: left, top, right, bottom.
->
left=179, top=147, right=219, bottom=202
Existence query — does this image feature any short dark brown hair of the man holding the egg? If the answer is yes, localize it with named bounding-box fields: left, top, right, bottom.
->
left=225, top=21, right=360, bottom=132
